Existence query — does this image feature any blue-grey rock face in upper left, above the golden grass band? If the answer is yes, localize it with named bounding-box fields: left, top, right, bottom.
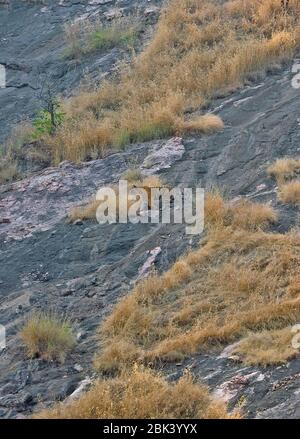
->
left=0, top=0, right=161, bottom=145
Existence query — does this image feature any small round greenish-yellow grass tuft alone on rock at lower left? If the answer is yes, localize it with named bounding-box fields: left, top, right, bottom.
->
left=19, top=313, right=75, bottom=362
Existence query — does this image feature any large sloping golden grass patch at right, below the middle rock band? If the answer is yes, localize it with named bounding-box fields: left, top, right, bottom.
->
left=94, top=192, right=300, bottom=371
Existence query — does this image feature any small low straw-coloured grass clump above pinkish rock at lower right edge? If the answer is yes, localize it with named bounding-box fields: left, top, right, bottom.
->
left=234, top=327, right=299, bottom=366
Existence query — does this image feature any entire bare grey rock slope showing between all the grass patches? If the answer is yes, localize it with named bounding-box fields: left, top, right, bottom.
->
left=0, top=0, right=300, bottom=418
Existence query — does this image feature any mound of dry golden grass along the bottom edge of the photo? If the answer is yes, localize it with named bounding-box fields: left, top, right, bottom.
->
left=35, top=367, right=240, bottom=419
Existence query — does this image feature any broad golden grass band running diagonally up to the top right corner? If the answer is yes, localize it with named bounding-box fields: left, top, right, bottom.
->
left=45, top=0, right=300, bottom=162
